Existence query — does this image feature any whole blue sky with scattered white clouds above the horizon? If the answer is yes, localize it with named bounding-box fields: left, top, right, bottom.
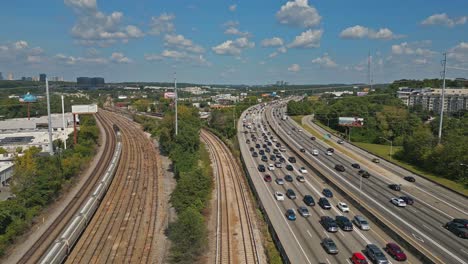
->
left=0, top=0, right=468, bottom=84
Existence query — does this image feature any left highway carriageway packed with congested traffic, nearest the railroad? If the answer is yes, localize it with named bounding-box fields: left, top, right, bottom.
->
left=238, top=103, right=420, bottom=263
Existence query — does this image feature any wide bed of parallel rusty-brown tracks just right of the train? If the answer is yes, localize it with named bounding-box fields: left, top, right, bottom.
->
left=67, top=111, right=166, bottom=263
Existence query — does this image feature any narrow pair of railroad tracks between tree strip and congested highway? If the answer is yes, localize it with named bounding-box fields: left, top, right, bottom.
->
left=200, top=130, right=264, bottom=263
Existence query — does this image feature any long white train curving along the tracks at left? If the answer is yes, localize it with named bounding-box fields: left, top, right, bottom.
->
left=39, top=138, right=122, bottom=264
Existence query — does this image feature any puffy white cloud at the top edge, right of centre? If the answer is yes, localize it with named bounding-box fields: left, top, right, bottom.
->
left=276, top=0, right=322, bottom=27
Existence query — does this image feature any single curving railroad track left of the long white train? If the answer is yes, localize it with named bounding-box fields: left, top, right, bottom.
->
left=17, top=112, right=117, bottom=264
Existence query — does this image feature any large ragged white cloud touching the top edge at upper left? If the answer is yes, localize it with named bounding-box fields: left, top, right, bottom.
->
left=65, top=0, right=144, bottom=45
